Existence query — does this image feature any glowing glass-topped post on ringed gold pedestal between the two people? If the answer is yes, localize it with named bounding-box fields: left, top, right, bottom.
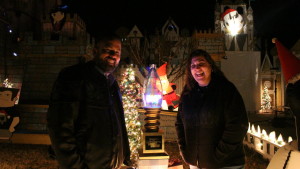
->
left=138, top=64, right=169, bottom=169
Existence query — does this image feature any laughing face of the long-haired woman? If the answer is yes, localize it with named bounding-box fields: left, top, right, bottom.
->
left=191, top=56, right=212, bottom=86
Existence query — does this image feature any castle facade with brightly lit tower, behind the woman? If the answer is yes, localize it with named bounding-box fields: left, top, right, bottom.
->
left=118, top=1, right=261, bottom=112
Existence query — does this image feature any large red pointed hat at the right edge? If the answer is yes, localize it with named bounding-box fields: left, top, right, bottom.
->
left=272, top=38, right=300, bottom=83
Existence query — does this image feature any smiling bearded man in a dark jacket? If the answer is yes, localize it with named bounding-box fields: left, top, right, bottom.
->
left=47, top=36, right=130, bottom=169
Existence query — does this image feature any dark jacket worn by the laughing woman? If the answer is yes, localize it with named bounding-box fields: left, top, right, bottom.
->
left=175, top=75, right=248, bottom=168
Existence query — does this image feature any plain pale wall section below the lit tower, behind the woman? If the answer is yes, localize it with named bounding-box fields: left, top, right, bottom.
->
left=221, top=51, right=261, bottom=112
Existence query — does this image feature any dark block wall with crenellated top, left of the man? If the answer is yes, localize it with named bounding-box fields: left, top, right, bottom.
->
left=0, top=9, right=94, bottom=104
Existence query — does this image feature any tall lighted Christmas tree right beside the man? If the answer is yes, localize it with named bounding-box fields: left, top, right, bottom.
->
left=120, top=65, right=142, bottom=166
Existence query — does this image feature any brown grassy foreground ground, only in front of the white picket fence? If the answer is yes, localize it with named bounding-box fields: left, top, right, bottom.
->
left=0, top=142, right=269, bottom=169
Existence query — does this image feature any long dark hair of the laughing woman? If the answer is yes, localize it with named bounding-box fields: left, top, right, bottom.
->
left=181, top=49, right=225, bottom=95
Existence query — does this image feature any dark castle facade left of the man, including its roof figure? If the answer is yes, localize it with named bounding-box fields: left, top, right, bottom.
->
left=0, top=1, right=94, bottom=132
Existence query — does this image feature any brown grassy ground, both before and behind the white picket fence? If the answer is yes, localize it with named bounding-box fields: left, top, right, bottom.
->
left=0, top=111, right=296, bottom=169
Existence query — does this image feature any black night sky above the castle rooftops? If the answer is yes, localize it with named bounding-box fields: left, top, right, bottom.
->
left=63, top=0, right=300, bottom=48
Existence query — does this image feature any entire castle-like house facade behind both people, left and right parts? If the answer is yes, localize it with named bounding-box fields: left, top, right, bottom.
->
left=0, top=0, right=299, bottom=137
